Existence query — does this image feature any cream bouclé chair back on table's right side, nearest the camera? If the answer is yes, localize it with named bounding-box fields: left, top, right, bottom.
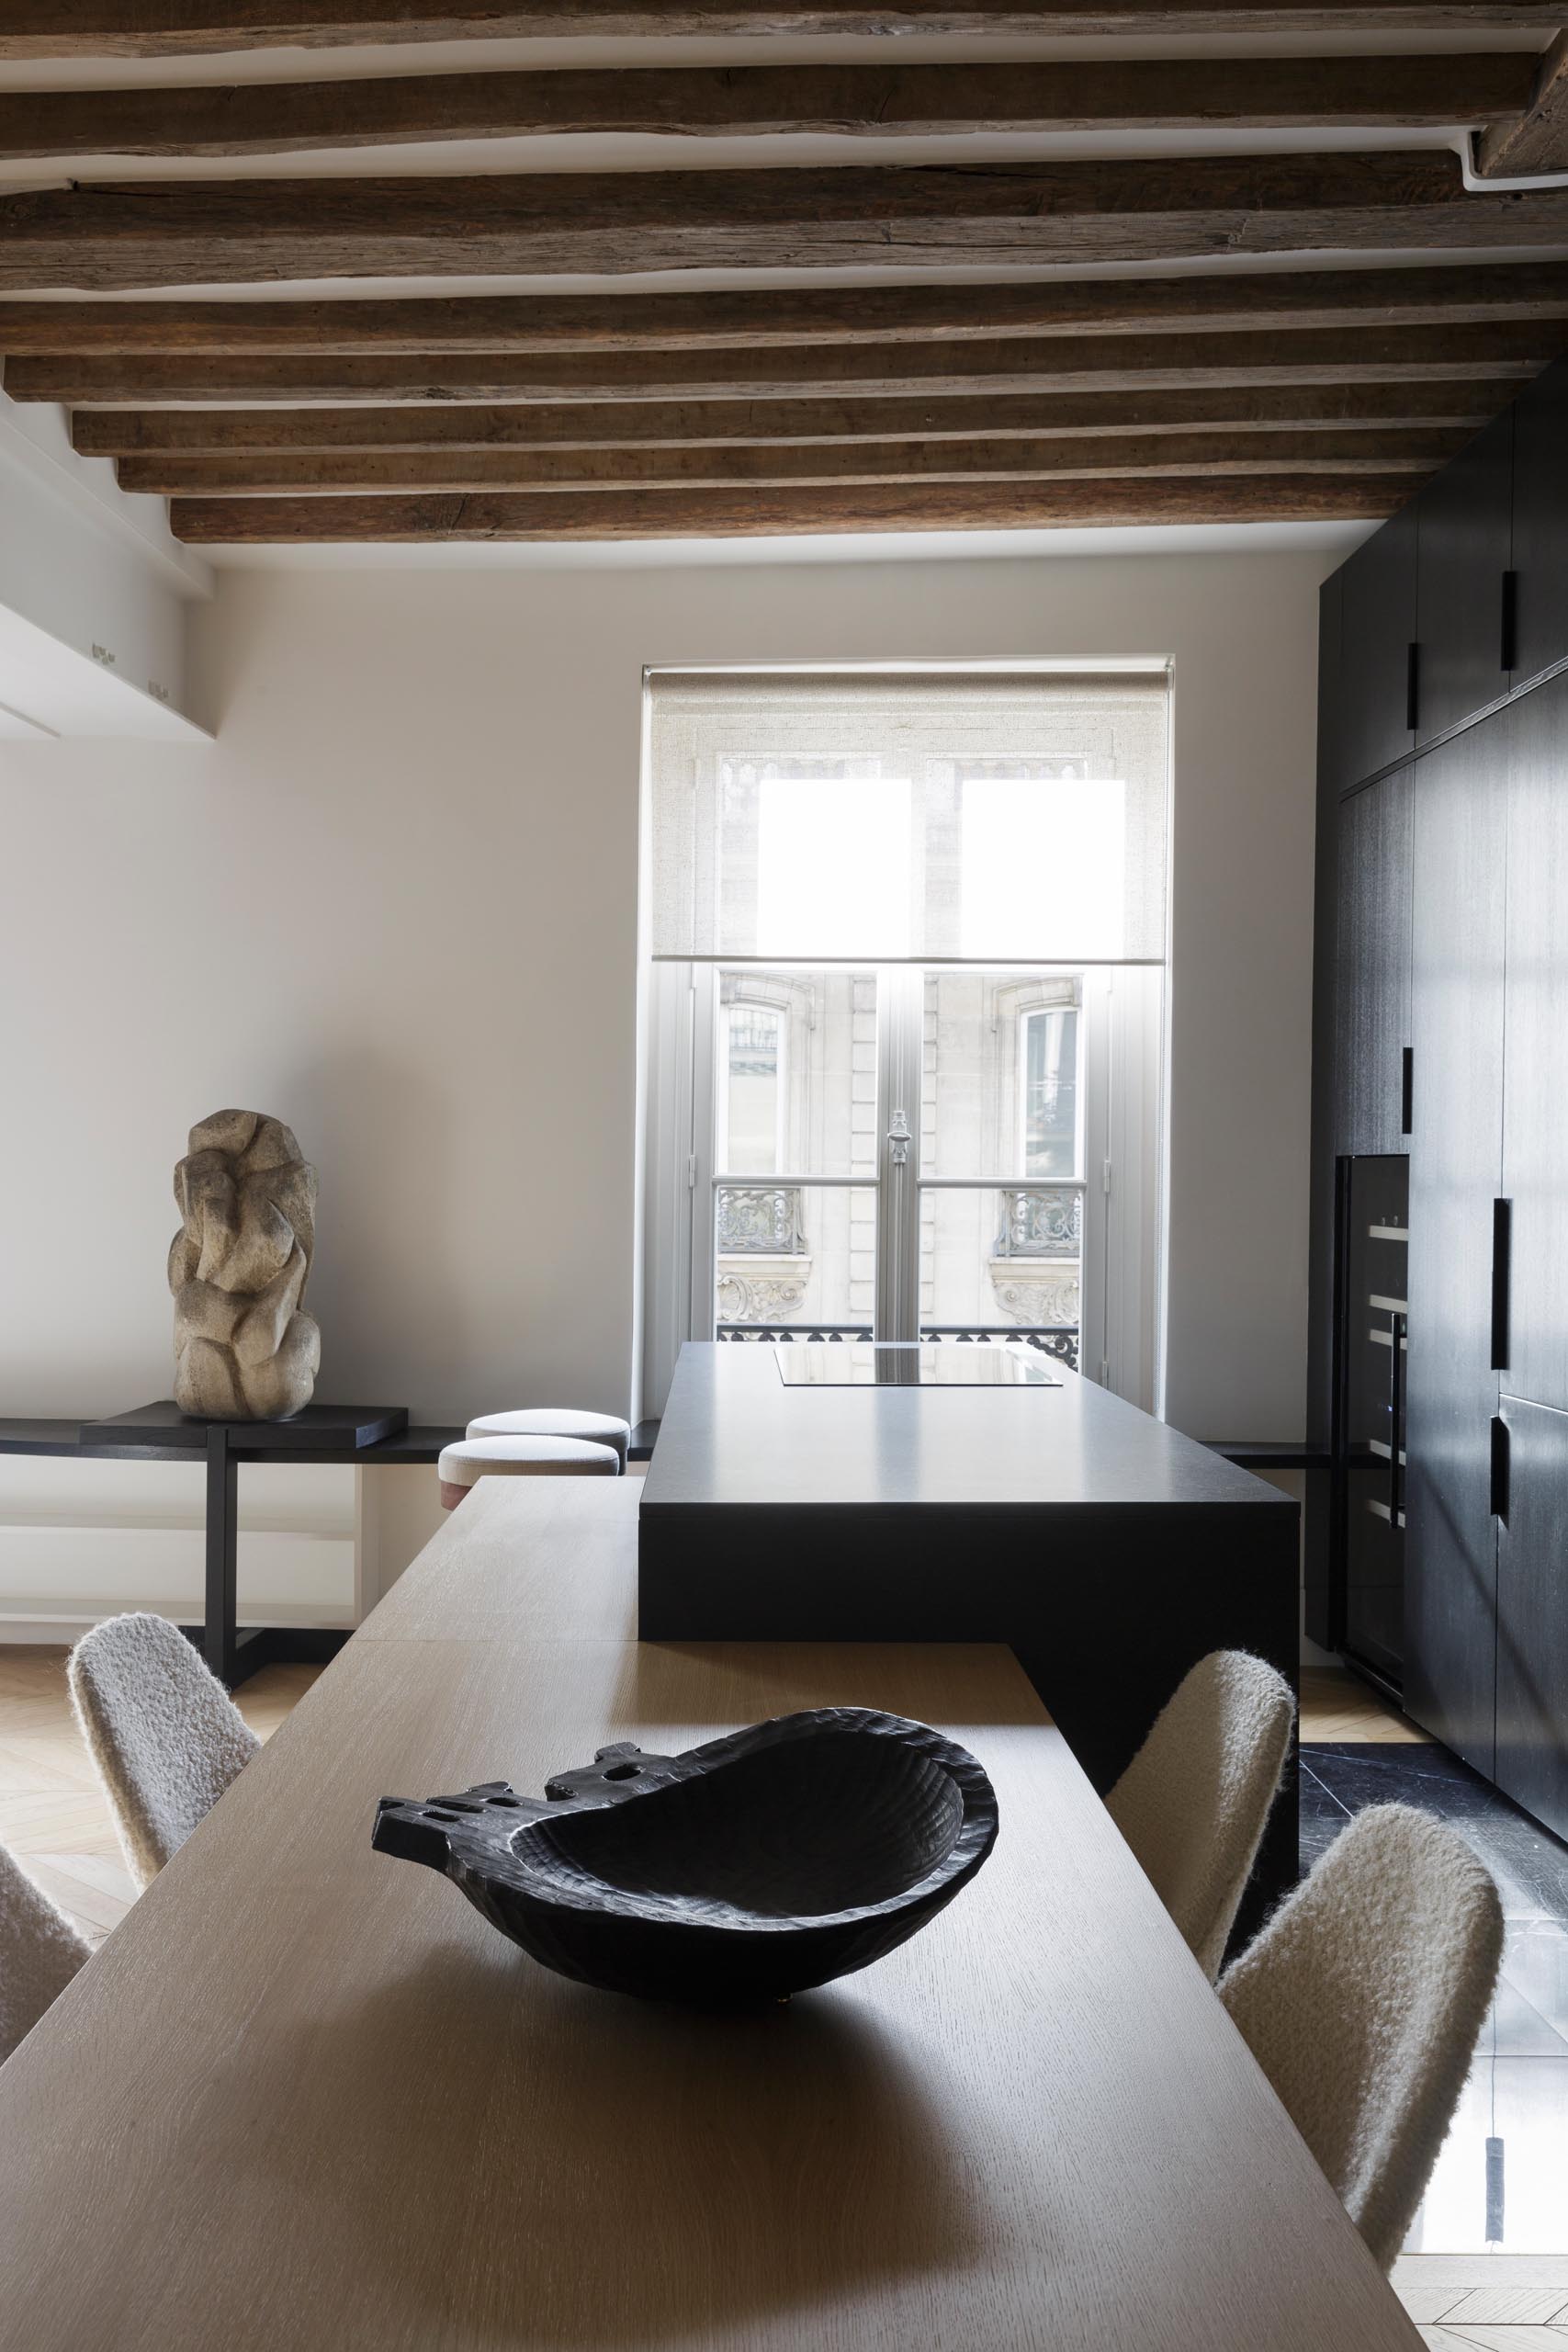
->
left=1220, top=1804, right=1502, bottom=2269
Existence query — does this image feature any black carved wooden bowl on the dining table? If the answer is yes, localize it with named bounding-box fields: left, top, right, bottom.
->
left=371, top=1708, right=997, bottom=2004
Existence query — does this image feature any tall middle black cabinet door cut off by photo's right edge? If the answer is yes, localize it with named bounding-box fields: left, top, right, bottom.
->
left=1488, top=675, right=1568, bottom=1420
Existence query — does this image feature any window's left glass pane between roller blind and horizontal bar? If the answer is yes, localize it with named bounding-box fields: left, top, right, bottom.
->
left=712, top=965, right=877, bottom=1179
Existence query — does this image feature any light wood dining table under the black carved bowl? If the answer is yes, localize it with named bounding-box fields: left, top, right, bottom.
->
left=0, top=1479, right=1417, bottom=2352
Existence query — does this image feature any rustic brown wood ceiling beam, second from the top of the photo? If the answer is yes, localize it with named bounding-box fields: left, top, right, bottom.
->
left=0, top=50, right=1535, bottom=158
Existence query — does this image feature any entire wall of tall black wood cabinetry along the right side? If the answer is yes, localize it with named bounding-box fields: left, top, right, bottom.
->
left=1307, top=360, right=1568, bottom=1837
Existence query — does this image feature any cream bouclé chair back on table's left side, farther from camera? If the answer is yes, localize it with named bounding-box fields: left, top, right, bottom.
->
left=71, top=1613, right=261, bottom=1886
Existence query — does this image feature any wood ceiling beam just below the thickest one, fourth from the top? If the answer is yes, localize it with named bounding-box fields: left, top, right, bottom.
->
left=12, top=261, right=1568, bottom=360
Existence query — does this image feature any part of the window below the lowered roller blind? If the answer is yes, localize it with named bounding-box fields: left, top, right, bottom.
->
left=647, top=962, right=1159, bottom=1411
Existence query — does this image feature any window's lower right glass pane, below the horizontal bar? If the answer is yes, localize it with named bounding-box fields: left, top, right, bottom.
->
left=919, top=1185, right=1084, bottom=1369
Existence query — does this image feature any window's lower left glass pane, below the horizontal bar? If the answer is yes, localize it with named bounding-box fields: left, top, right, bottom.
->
left=715, top=1183, right=877, bottom=1339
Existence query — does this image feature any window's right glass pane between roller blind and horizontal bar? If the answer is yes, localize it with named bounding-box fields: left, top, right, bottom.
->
left=919, top=971, right=1084, bottom=1183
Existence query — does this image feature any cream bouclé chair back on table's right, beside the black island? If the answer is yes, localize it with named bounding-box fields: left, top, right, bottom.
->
left=1105, top=1649, right=1295, bottom=1983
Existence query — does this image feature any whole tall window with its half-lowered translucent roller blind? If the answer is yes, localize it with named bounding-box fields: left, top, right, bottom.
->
left=647, top=671, right=1168, bottom=1411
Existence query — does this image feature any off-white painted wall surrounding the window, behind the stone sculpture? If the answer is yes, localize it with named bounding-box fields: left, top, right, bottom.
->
left=0, top=550, right=1337, bottom=1437
